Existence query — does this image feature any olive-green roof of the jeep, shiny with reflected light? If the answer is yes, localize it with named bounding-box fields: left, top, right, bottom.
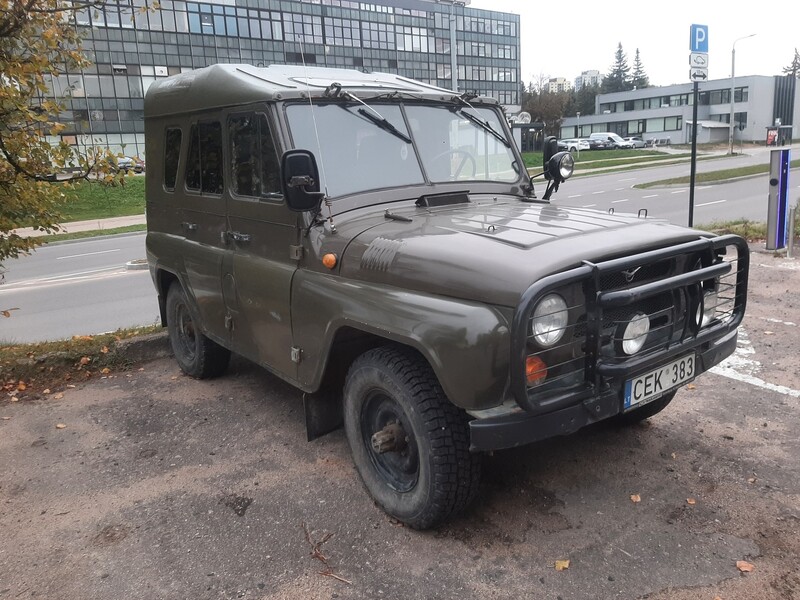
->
left=144, top=64, right=497, bottom=117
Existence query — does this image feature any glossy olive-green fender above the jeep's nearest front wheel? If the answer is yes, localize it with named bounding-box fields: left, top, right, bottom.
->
left=292, top=270, right=510, bottom=409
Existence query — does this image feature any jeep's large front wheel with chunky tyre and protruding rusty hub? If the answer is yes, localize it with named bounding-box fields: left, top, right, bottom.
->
left=344, top=346, right=480, bottom=529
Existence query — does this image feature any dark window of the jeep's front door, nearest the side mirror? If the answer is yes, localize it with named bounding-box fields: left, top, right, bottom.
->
left=228, top=113, right=281, bottom=198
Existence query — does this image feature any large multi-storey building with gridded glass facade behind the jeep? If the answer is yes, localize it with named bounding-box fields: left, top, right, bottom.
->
left=47, top=0, right=520, bottom=156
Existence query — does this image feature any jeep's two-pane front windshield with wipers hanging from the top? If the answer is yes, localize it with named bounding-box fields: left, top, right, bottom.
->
left=286, top=103, right=519, bottom=198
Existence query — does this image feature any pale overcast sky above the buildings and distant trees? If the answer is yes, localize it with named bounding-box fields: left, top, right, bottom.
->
left=470, top=0, right=800, bottom=85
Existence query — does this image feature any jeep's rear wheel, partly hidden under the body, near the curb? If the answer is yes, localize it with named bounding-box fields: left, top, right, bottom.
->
left=167, top=281, right=231, bottom=379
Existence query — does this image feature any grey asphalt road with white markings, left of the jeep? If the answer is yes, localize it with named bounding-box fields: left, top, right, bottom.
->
left=0, top=233, right=159, bottom=342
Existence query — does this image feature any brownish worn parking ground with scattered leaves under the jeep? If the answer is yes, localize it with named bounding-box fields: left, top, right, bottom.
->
left=0, top=245, right=800, bottom=600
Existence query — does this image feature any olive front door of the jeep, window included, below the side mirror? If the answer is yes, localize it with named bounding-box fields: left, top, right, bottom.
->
left=224, top=111, right=300, bottom=379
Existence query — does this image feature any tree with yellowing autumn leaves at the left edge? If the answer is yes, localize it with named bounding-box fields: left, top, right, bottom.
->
left=0, top=0, right=121, bottom=267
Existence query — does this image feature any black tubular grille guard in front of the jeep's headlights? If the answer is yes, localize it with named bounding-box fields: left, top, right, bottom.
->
left=510, top=235, right=750, bottom=413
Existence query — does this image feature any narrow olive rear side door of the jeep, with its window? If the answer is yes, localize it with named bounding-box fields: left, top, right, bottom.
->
left=180, top=119, right=228, bottom=344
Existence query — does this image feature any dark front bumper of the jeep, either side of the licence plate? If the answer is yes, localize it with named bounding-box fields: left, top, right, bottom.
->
left=469, top=331, right=737, bottom=452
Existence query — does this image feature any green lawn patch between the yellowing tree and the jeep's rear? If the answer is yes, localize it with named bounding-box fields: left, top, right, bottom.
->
left=61, top=176, right=145, bottom=223
